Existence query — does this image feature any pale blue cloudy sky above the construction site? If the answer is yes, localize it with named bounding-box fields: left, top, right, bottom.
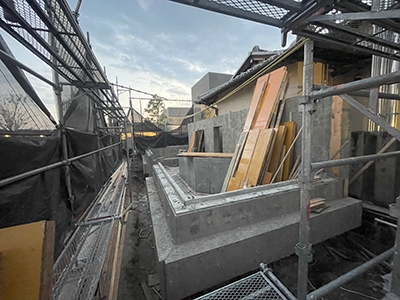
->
left=2, top=0, right=294, bottom=119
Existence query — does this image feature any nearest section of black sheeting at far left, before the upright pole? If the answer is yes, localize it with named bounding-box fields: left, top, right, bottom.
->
left=0, top=130, right=72, bottom=254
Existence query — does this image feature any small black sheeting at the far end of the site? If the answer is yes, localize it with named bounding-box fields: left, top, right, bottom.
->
left=134, top=131, right=188, bottom=155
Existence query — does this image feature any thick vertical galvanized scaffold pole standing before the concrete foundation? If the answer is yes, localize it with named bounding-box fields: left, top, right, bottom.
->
left=296, top=41, right=314, bottom=300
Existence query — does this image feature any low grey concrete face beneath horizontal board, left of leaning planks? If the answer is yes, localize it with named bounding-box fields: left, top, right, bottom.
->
left=179, top=157, right=231, bottom=194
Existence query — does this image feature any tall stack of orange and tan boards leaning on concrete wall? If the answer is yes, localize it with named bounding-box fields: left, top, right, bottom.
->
left=221, top=67, right=296, bottom=192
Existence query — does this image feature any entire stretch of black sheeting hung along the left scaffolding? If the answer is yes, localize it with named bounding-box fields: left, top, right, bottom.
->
left=0, top=129, right=122, bottom=256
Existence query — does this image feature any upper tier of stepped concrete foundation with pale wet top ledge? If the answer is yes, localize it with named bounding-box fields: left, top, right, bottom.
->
left=153, top=166, right=343, bottom=243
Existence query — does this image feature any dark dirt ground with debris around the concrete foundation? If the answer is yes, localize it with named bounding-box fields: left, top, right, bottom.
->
left=118, top=174, right=394, bottom=300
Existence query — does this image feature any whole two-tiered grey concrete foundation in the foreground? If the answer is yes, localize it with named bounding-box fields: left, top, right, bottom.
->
left=147, top=165, right=362, bottom=299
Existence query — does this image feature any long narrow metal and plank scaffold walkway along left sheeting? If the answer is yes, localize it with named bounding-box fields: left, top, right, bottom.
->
left=53, top=162, right=127, bottom=300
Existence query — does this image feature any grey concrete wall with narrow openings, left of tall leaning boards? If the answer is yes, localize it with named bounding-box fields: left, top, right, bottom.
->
left=188, top=109, right=248, bottom=153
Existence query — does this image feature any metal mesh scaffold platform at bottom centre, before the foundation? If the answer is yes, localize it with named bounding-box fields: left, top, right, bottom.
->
left=196, top=272, right=287, bottom=300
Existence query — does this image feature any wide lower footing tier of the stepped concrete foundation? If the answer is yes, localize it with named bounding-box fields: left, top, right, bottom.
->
left=147, top=178, right=362, bottom=299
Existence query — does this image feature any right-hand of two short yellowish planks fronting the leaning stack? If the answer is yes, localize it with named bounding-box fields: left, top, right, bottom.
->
left=246, top=129, right=275, bottom=187
